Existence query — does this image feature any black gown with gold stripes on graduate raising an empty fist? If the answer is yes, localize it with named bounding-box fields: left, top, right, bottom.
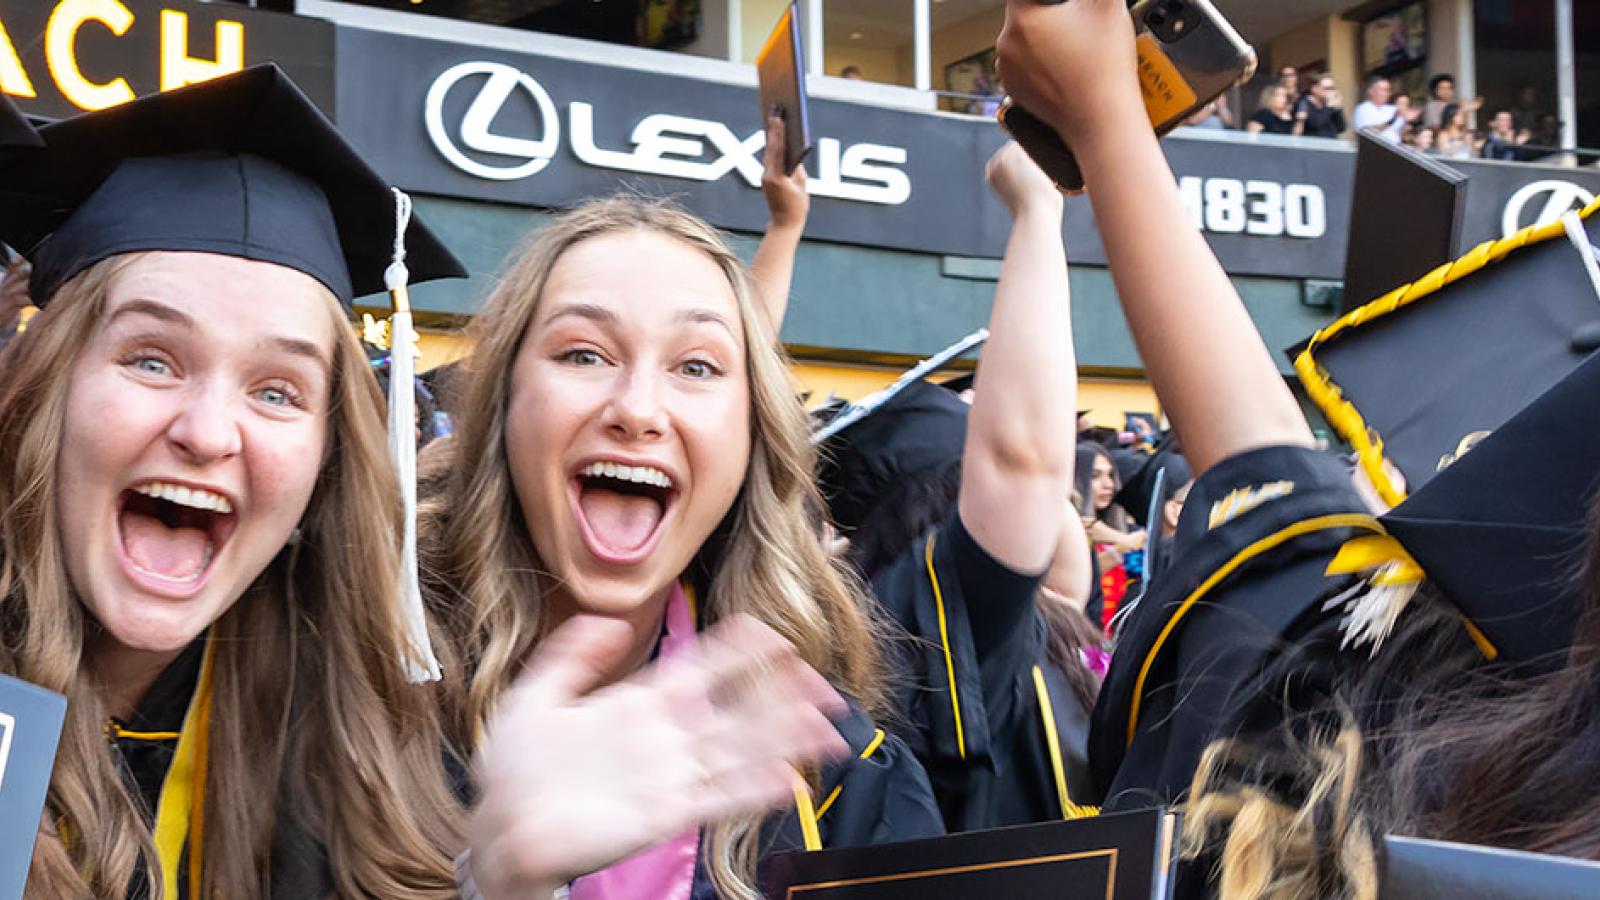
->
left=872, top=512, right=1091, bottom=833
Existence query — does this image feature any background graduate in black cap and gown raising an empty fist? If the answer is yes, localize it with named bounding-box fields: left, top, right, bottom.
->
left=822, top=144, right=1098, bottom=831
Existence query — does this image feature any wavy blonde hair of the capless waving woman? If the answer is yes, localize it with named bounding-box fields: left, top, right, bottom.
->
left=421, top=197, right=878, bottom=898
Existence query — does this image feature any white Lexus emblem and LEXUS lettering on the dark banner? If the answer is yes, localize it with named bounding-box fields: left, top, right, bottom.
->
left=422, top=61, right=910, bottom=207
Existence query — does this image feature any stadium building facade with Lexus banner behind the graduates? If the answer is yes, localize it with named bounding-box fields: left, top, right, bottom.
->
left=0, top=0, right=1600, bottom=426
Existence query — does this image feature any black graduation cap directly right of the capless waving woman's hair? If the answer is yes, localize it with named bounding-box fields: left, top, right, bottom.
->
left=818, top=380, right=970, bottom=532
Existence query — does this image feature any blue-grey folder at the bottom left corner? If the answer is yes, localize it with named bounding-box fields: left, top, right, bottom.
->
left=0, top=674, right=67, bottom=900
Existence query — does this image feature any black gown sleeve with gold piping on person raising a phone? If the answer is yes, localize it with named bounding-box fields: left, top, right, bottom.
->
left=1090, top=447, right=1382, bottom=812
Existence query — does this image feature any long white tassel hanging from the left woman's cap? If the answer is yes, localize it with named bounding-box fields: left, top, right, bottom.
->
left=384, top=189, right=442, bottom=682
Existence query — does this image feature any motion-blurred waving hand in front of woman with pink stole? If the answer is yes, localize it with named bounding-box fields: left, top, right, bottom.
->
left=469, top=617, right=846, bottom=900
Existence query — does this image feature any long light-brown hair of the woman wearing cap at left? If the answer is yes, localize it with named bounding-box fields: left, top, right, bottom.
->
left=0, top=255, right=462, bottom=900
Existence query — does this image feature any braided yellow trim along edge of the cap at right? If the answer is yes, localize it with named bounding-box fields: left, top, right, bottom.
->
left=1294, top=199, right=1600, bottom=506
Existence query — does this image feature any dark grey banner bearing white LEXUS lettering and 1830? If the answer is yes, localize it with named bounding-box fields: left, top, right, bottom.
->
left=338, top=27, right=1352, bottom=279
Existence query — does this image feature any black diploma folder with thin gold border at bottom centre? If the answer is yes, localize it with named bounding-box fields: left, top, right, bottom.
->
left=762, top=809, right=1178, bottom=900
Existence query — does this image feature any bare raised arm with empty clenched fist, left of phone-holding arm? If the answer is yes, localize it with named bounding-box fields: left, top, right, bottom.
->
left=960, top=144, right=1077, bottom=572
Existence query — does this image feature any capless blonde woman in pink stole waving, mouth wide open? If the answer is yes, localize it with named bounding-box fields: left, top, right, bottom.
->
left=422, top=199, right=941, bottom=898
